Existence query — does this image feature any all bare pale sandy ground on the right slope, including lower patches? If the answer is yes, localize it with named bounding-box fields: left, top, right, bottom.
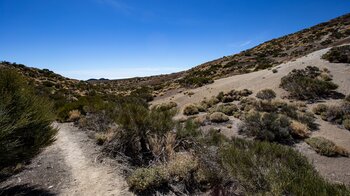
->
left=152, top=45, right=350, bottom=184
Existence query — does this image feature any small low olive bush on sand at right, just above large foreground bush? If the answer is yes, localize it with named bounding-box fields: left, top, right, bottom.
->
left=305, top=137, right=349, bottom=157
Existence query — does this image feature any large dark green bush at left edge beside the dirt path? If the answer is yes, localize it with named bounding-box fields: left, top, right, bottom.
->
left=0, top=69, right=57, bottom=170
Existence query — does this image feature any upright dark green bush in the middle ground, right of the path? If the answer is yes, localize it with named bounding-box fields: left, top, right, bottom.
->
left=108, top=103, right=176, bottom=165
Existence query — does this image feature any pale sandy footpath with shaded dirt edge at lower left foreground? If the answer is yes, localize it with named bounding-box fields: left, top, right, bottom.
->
left=0, top=124, right=132, bottom=196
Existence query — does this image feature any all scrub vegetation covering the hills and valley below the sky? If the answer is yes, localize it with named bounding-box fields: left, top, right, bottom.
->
left=0, top=15, right=350, bottom=195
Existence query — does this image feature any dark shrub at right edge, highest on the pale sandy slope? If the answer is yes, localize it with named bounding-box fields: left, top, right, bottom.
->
left=322, top=45, right=350, bottom=63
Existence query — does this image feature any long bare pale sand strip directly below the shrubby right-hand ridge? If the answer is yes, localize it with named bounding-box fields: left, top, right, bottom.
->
left=152, top=49, right=350, bottom=107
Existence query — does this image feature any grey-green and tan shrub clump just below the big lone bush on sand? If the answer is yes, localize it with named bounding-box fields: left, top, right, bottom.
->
left=240, top=98, right=317, bottom=144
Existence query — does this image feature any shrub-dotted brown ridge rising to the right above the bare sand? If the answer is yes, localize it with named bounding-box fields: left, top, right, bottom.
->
left=183, top=14, right=350, bottom=85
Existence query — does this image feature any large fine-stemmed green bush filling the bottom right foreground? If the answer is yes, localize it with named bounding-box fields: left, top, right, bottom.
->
left=219, top=139, right=350, bottom=195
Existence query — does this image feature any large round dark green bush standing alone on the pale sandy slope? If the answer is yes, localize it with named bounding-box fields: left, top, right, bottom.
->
left=280, top=66, right=338, bottom=100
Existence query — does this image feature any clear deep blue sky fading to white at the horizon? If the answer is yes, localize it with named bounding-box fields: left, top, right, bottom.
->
left=0, top=0, right=350, bottom=79
